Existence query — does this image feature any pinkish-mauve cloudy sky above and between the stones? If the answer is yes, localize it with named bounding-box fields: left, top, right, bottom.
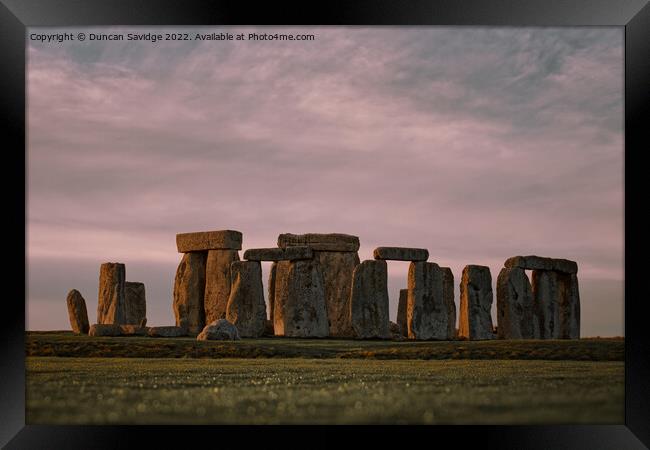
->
left=26, top=26, right=624, bottom=336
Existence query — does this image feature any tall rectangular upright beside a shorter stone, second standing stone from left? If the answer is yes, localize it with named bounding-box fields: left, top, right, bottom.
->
left=97, top=263, right=126, bottom=324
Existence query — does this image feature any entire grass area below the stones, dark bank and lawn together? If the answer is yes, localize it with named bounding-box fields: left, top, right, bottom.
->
left=26, top=332, right=624, bottom=424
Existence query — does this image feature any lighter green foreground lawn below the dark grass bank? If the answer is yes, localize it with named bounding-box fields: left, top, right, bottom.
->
left=26, top=356, right=624, bottom=424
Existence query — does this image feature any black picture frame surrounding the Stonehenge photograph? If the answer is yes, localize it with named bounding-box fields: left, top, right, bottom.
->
left=0, top=0, right=650, bottom=449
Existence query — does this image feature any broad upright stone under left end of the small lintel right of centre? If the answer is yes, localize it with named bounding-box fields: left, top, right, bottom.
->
left=350, top=260, right=390, bottom=339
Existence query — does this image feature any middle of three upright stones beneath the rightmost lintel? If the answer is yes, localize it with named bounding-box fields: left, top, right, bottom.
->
left=531, top=270, right=562, bottom=339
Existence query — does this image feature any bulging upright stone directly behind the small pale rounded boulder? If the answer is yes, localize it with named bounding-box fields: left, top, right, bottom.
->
left=226, top=261, right=266, bottom=337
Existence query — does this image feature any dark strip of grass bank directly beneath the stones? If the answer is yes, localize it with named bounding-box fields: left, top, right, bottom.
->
left=26, top=332, right=625, bottom=361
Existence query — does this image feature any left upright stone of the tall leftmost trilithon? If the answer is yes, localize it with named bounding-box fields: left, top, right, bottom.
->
left=174, top=252, right=207, bottom=334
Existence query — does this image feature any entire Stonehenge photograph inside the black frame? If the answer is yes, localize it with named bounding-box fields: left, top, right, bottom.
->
left=25, top=25, right=626, bottom=426
